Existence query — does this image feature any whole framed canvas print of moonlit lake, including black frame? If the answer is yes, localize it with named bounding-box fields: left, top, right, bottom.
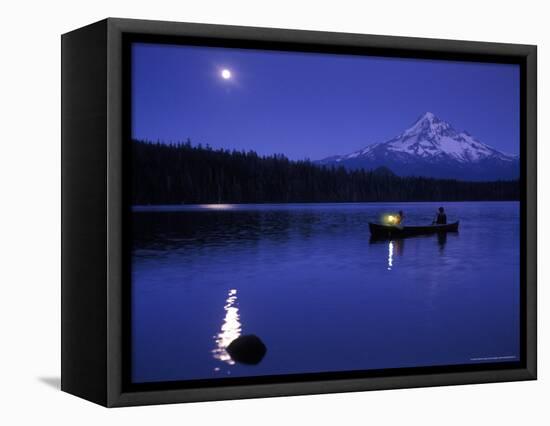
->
left=62, top=19, right=536, bottom=406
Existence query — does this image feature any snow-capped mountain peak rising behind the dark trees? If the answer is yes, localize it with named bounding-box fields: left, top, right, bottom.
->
left=318, top=112, right=519, bottom=180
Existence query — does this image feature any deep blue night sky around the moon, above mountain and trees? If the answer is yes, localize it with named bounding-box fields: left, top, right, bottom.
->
left=132, top=43, right=519, bottom=160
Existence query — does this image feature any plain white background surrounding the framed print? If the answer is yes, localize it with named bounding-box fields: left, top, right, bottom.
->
left=0, top=0, right=550, bottom=426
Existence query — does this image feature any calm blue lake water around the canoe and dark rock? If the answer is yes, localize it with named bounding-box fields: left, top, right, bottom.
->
left=132, top=202, right=519, bottom=382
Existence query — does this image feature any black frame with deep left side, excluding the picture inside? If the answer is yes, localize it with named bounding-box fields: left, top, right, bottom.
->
left=61, top=18, right=537, bottom=407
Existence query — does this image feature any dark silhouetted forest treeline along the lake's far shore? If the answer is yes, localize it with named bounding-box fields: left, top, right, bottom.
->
left=132, top=141, right=519, bottom=205
